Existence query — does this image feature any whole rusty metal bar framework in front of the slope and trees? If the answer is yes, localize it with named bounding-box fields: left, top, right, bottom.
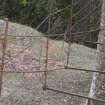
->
left=0, top=0, right=105, bottom=103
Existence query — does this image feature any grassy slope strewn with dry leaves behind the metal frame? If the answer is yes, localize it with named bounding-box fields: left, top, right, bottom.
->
left=0, top=21, right=96, bottom=105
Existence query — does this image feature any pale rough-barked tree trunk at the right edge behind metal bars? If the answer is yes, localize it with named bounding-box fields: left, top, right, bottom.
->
left=87, top=0, right=105, bottom=105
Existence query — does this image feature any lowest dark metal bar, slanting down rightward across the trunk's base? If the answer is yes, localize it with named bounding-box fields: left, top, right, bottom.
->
left=46, top=87, right=105, bottom=103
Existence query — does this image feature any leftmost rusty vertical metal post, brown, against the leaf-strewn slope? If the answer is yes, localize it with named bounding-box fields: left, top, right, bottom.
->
left=0, top=18, right=8, bottom=96
